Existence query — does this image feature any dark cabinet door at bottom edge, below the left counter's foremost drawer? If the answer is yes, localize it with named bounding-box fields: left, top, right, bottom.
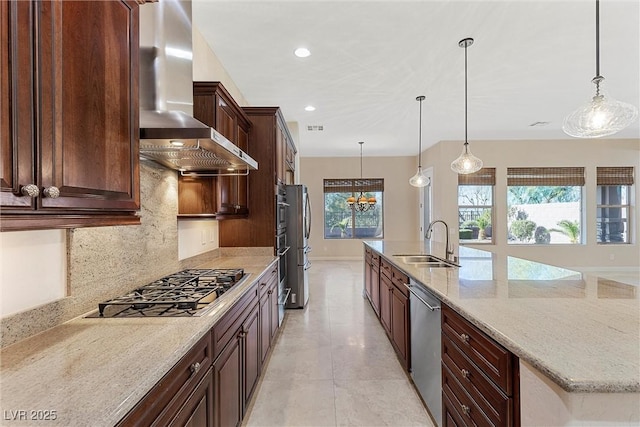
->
left=169, top=368, right=214, bottom=427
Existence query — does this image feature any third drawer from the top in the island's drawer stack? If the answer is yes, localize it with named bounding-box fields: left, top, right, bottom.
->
left=442, top=363, right=495, bottom=427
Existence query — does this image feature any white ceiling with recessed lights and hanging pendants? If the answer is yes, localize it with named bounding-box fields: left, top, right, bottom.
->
left=193, top=0, right=640, bottom=156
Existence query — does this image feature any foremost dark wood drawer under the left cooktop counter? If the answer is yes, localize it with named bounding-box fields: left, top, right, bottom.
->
left=118, top=334, right=213, bottom=426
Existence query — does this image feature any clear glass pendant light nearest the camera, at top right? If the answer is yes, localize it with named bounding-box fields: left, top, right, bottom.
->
left=562, top=0, right=638, bottom=138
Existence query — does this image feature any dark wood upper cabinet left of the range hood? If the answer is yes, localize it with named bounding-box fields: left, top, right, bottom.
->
left=0, top=0, right=140, bottom=231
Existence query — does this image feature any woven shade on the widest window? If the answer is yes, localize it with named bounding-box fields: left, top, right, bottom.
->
left=507, top=167, right=584, bottom=187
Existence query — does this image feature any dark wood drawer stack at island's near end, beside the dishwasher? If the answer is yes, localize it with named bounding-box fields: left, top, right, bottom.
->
left=442, top=304, right=520, bottom=426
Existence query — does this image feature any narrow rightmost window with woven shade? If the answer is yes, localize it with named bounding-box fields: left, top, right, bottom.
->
left=596, top=167, right=633, bottom=243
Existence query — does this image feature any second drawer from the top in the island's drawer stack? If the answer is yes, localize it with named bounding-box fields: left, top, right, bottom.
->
left=442, top=335, right=513, bottom=425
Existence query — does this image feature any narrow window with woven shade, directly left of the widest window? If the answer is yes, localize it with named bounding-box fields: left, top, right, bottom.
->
left=458, top=168, right=496, bottom=244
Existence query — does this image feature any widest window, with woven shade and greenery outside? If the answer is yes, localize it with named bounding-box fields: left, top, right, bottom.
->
left=507, top=167, right=584, bottom=244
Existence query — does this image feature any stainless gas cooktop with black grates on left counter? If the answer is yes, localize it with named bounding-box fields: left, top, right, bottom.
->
left=89, top=268, right=245, bottom=317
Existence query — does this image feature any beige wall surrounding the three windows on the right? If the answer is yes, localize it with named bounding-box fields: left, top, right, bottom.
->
left=423, top=139, right=640, bottom=270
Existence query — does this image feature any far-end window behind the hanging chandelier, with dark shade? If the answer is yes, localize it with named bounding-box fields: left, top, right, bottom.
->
left=324, top=178, right=384, bottom=239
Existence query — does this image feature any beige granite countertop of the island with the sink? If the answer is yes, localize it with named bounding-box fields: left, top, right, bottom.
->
left=365, top=241, right=640, bottom=393
